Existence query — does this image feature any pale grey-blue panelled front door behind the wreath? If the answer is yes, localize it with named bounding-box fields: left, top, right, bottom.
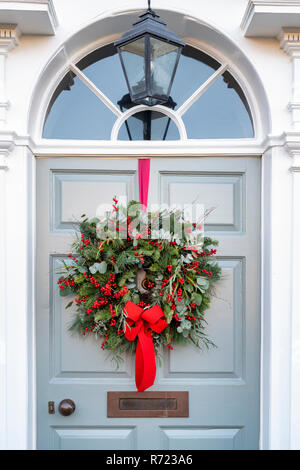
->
left=36, top=158, right=260, bottom=450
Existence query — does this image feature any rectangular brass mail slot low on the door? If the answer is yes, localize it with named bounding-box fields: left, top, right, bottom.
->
left=107, top=391, right=189, bottom=418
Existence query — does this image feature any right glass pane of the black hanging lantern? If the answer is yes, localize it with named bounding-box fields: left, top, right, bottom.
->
left=150, top=37, right=180, bottom=96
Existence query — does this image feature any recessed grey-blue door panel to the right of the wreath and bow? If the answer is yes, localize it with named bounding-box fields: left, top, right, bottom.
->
left=169, top=259, right=245, bottom=378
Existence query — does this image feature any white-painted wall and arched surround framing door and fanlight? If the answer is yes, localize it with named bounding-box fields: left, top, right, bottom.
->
left=0, top=0, right=300, bottom=449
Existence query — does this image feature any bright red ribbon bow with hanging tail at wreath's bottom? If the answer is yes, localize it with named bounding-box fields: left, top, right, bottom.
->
left=123, top=300, right=168, bottom=392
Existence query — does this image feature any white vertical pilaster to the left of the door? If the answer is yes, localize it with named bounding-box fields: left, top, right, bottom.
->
left=0, top=144, right=35, bottom=450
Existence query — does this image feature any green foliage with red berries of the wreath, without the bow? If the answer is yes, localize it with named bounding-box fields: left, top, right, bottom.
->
left=60, top=201, right=221, bottom=363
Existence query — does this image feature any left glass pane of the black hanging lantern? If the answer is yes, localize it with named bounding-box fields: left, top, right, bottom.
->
left=120, top=38, right=146, bottom=97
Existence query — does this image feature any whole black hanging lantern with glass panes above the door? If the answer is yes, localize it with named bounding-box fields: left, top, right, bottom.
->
left=115, top=1, right=185, bottom=106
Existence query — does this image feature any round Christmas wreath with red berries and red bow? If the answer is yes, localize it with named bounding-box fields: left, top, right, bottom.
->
left=58, top=199, right=221, bottom=391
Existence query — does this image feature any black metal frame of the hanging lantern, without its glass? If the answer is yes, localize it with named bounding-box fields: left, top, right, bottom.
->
left=115, top=2, right=185, bottom=106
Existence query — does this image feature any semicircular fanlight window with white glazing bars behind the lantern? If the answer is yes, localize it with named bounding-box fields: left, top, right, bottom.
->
left=43, top=44, right=254, bottom=141
